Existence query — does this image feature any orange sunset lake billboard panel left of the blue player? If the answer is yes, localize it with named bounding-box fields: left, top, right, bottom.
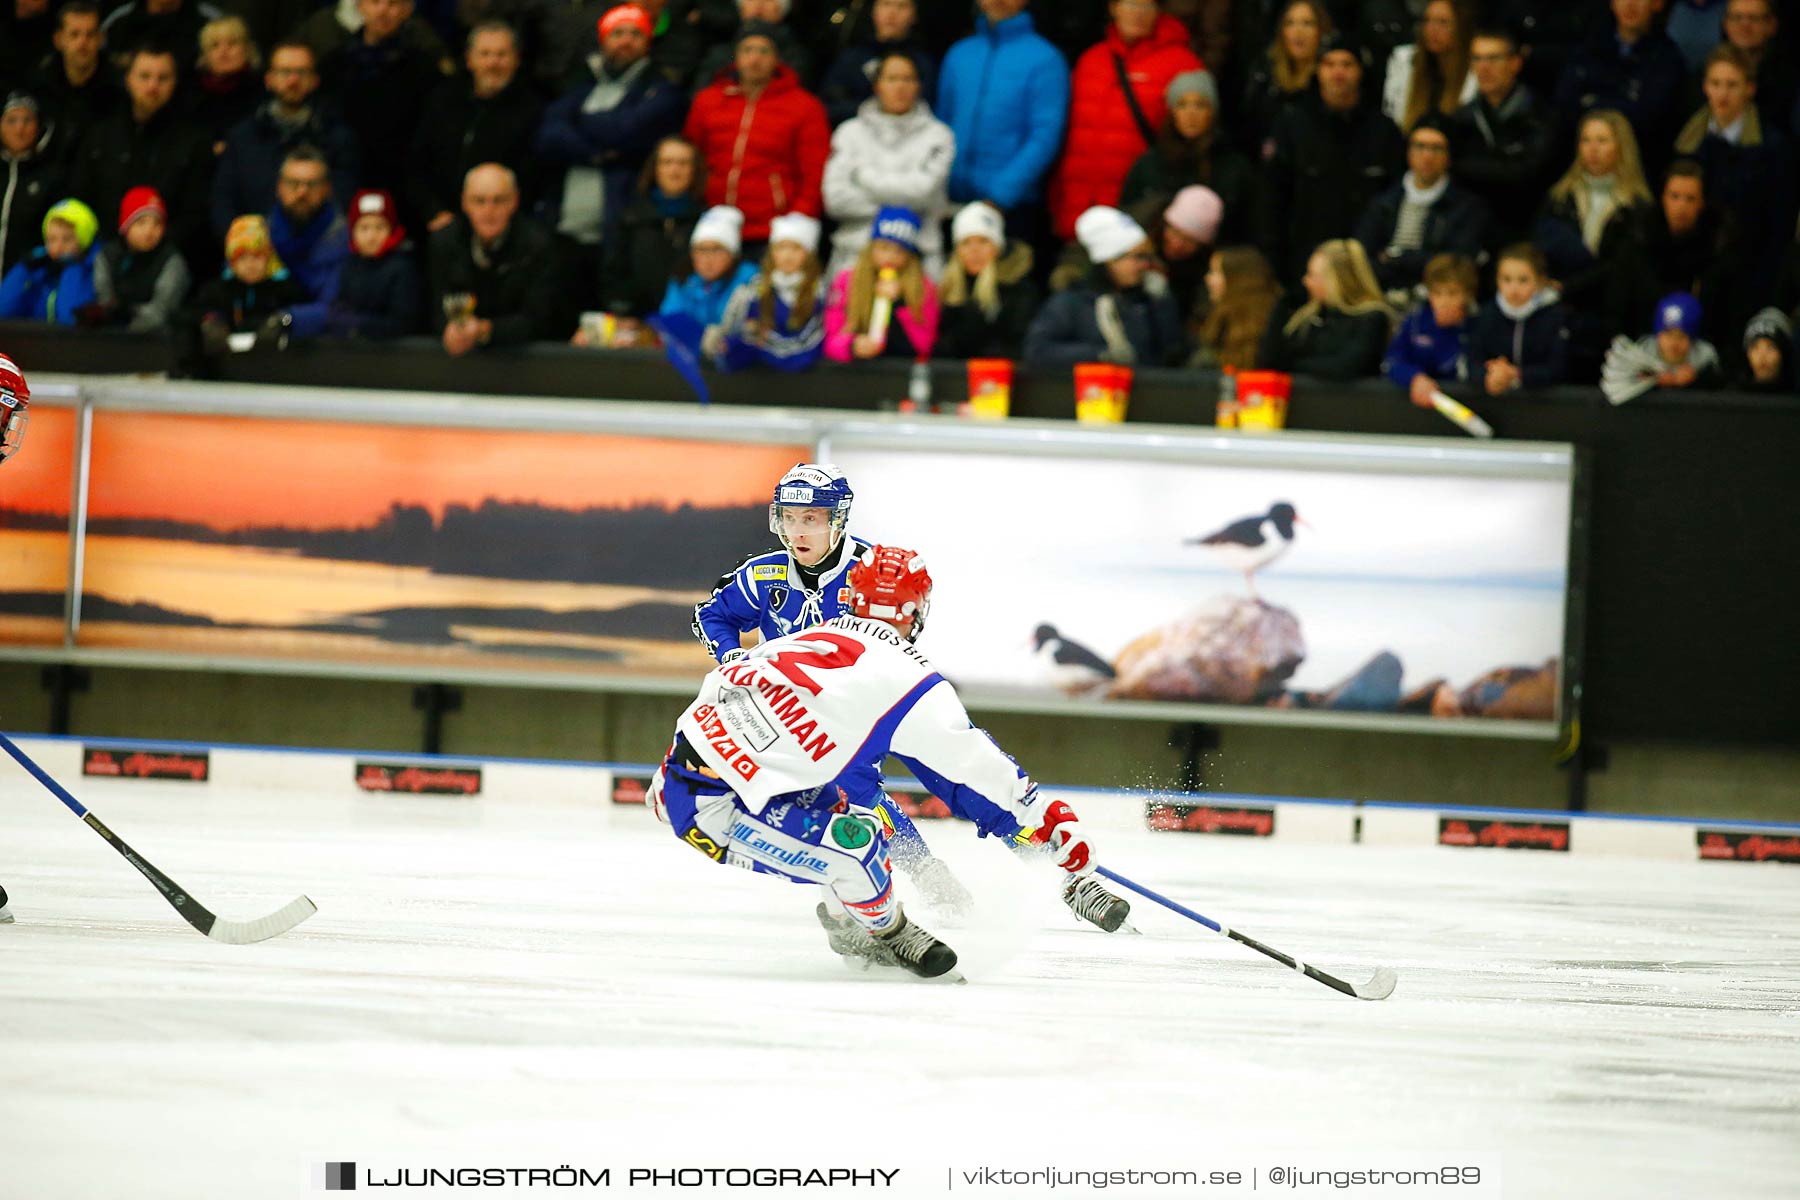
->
left=61, top=410, right=810, bottom=680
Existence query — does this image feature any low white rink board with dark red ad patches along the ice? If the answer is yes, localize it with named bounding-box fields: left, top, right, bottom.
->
left=16, top=736, right=1800, bottom=864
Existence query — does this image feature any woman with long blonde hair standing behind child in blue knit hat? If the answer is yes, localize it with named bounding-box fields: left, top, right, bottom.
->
left=1532, top=108, right=1654, bottom=381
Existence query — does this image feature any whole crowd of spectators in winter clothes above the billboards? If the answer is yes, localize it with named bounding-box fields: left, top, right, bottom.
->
left=0, top=0, right=1800, bottom=405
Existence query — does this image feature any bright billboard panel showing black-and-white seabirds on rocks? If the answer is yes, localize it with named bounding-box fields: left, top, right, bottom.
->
left=833, top=446, right=1570, bottom=721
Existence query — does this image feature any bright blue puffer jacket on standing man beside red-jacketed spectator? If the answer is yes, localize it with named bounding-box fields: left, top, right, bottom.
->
left=938, top=13, right=1069, bottom=212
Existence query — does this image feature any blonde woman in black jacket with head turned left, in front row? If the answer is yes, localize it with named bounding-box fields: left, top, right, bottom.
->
left=1256, top=237, right=1395, bottom=380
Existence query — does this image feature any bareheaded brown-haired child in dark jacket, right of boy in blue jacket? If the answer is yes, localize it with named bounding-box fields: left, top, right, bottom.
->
left=1469, top=241, right=1570, bottom=396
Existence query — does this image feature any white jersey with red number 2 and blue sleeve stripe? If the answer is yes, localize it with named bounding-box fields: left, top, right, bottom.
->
left=679, top=617, right=1042, bottom=826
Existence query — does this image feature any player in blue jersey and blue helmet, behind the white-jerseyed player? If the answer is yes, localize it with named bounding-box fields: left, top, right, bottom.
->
left=693, top=462, right=970, bottom=912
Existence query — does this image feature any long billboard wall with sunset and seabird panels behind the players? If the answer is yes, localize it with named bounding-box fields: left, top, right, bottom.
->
left=0, top=378, right=1586, bottom=739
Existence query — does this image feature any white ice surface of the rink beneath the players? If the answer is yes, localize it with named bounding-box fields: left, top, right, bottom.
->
left=0, top=763, right=1800, bottom=1200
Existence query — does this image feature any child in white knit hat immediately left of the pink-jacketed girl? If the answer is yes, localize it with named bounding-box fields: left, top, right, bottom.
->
left=706, top=212, right=824, bottom=371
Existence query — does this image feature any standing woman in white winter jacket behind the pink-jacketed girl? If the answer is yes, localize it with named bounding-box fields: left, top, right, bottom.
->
left=824, top=50, right=956, bottom=279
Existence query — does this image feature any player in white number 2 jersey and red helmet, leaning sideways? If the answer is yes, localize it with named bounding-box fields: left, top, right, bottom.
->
left=650, top=547, right=1103, bottom=977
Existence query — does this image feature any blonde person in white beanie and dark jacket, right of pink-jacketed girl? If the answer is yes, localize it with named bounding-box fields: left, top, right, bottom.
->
left=936, top=200, right=1039, bottom=358
